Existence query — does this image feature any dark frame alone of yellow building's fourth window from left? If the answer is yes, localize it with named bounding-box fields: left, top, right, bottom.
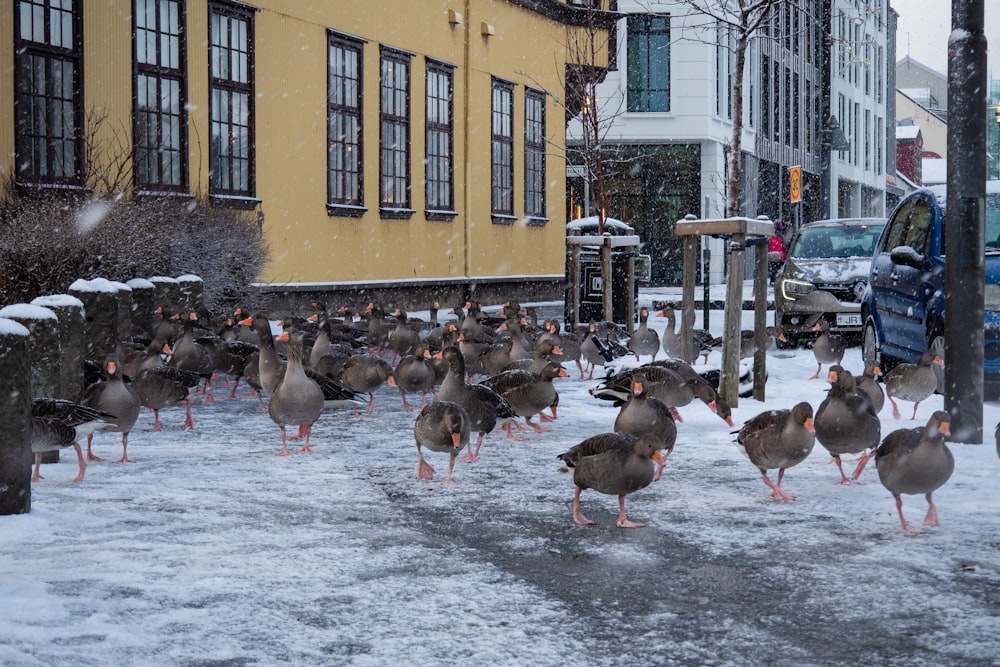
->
left=326, top=30, right=368, bottom=218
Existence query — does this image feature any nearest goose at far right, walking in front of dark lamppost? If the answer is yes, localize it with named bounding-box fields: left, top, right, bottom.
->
left=875, top=410, right=955, bottom=533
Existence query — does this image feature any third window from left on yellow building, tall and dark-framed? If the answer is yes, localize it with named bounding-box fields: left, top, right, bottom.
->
left=208, top=3, right=255, bottom=198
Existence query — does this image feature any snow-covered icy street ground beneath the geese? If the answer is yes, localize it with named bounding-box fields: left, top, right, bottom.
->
left=0, top=284, right=1000, bottom=666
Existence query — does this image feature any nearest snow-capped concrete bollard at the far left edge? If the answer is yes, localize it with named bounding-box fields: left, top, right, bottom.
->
left=0, top=318, right=32, bottom=515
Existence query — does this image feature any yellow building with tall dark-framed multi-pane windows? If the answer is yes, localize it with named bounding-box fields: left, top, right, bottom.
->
left=0, top=0, right=607, bottom=310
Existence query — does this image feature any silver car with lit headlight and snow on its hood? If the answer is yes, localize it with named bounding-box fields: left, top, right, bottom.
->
left=774, top=218, right=885, bottom=347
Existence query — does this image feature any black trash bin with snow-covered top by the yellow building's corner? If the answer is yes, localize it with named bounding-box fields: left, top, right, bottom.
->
left=565, top=216, right=644, bottom=326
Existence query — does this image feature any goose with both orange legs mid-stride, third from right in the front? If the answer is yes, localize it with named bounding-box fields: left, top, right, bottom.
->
left=736, top=401, right=816, bottom=500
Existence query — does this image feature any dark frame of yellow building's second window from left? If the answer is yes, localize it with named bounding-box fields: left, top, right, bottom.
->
left=132, top=0, right=189, bottom=192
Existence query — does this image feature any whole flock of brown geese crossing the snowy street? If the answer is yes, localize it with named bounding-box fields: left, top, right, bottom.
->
left=31, top=302, right=980, bottom=532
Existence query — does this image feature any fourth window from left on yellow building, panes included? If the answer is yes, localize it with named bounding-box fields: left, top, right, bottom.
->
left=326, top=33, right=364, bottom=217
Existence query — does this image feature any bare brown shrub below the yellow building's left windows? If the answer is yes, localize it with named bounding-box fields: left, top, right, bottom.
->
left=0, top=190, right=267, bottom=312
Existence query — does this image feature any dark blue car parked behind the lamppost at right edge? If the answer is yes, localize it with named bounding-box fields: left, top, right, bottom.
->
left=861, top=181, right=1000, bottom=394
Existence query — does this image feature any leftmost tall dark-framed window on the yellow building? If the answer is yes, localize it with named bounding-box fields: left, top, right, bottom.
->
left=14, top=0, right=83, bottom=185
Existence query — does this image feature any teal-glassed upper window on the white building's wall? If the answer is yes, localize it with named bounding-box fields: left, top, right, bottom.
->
left=627, top=15, right=670, bottom=111
